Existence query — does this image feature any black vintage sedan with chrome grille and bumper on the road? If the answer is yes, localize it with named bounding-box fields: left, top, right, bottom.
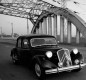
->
left=11, top=34, right=86, bottom=78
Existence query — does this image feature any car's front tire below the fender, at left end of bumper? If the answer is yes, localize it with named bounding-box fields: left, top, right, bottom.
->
left=34, top=63, right=45, bottom=80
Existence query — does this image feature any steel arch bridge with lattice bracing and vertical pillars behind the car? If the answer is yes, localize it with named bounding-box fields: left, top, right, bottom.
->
left=0, top=0, right=86, bottom=43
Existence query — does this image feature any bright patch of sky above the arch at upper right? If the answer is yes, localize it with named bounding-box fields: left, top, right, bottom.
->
left=67, top=0, right=86, bottom=22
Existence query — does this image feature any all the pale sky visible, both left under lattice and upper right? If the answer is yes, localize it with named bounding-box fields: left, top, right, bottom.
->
left=0, top=0, right=86, bottom=35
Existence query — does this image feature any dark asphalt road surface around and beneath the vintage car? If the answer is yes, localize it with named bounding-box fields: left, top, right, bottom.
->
left=0, top=44, right=86, bottom=80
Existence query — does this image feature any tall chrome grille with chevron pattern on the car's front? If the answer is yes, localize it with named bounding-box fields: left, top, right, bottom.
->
left=57, top=49, right=72, bottom=67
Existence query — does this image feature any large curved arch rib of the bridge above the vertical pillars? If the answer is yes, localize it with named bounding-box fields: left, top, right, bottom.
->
left=31, top=7, right=86, bottom=43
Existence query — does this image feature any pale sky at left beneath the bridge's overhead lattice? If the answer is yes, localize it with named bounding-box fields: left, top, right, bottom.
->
left=0, top=14, right=32, bottom=35
